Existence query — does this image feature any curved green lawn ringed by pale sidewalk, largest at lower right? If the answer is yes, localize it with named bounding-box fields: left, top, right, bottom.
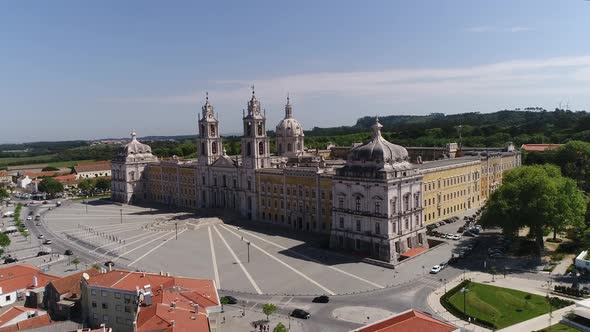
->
left=449, top=282, right=560, bottom=329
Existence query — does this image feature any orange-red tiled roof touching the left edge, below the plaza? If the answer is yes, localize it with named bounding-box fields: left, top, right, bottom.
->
left=0, top=264, right=59, bottom=294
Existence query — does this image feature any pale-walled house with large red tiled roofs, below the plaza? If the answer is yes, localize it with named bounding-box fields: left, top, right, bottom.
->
left=81, top=270, right=221, bottom=332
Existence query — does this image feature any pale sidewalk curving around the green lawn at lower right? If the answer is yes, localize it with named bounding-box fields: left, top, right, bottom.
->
left=428, top=272, right=572, bottom=332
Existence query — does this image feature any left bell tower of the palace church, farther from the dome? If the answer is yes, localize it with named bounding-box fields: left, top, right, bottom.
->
left=197, top=93, right=223, bottom=165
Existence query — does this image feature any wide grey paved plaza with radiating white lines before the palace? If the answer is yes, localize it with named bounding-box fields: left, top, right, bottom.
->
left=37, top=201, right=462, bottom=295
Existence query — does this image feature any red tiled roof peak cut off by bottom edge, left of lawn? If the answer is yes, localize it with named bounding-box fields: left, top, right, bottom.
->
left=354, top=310, right=459, bottom=332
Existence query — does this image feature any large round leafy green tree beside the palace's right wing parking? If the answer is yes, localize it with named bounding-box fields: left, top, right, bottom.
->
left=481, top=164, right=586, bottom=253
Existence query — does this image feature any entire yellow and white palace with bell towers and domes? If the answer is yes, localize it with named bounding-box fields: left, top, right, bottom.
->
left=112, top=91, right=520, bottom=263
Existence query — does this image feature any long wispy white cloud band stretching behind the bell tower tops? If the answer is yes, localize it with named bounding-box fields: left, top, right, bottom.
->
left=103, top=55, right=590, bottom=107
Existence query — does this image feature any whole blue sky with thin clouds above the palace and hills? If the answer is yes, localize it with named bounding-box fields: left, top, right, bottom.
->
left=0, top=0, right=590, bottom=142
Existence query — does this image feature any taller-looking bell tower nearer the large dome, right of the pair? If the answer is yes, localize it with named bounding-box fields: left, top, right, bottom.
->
left=242, top=86, right=270, bottom=169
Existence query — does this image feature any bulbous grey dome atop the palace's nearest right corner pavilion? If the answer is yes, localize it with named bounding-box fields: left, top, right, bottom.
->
left=348, top=119, right=408, bottom=164
